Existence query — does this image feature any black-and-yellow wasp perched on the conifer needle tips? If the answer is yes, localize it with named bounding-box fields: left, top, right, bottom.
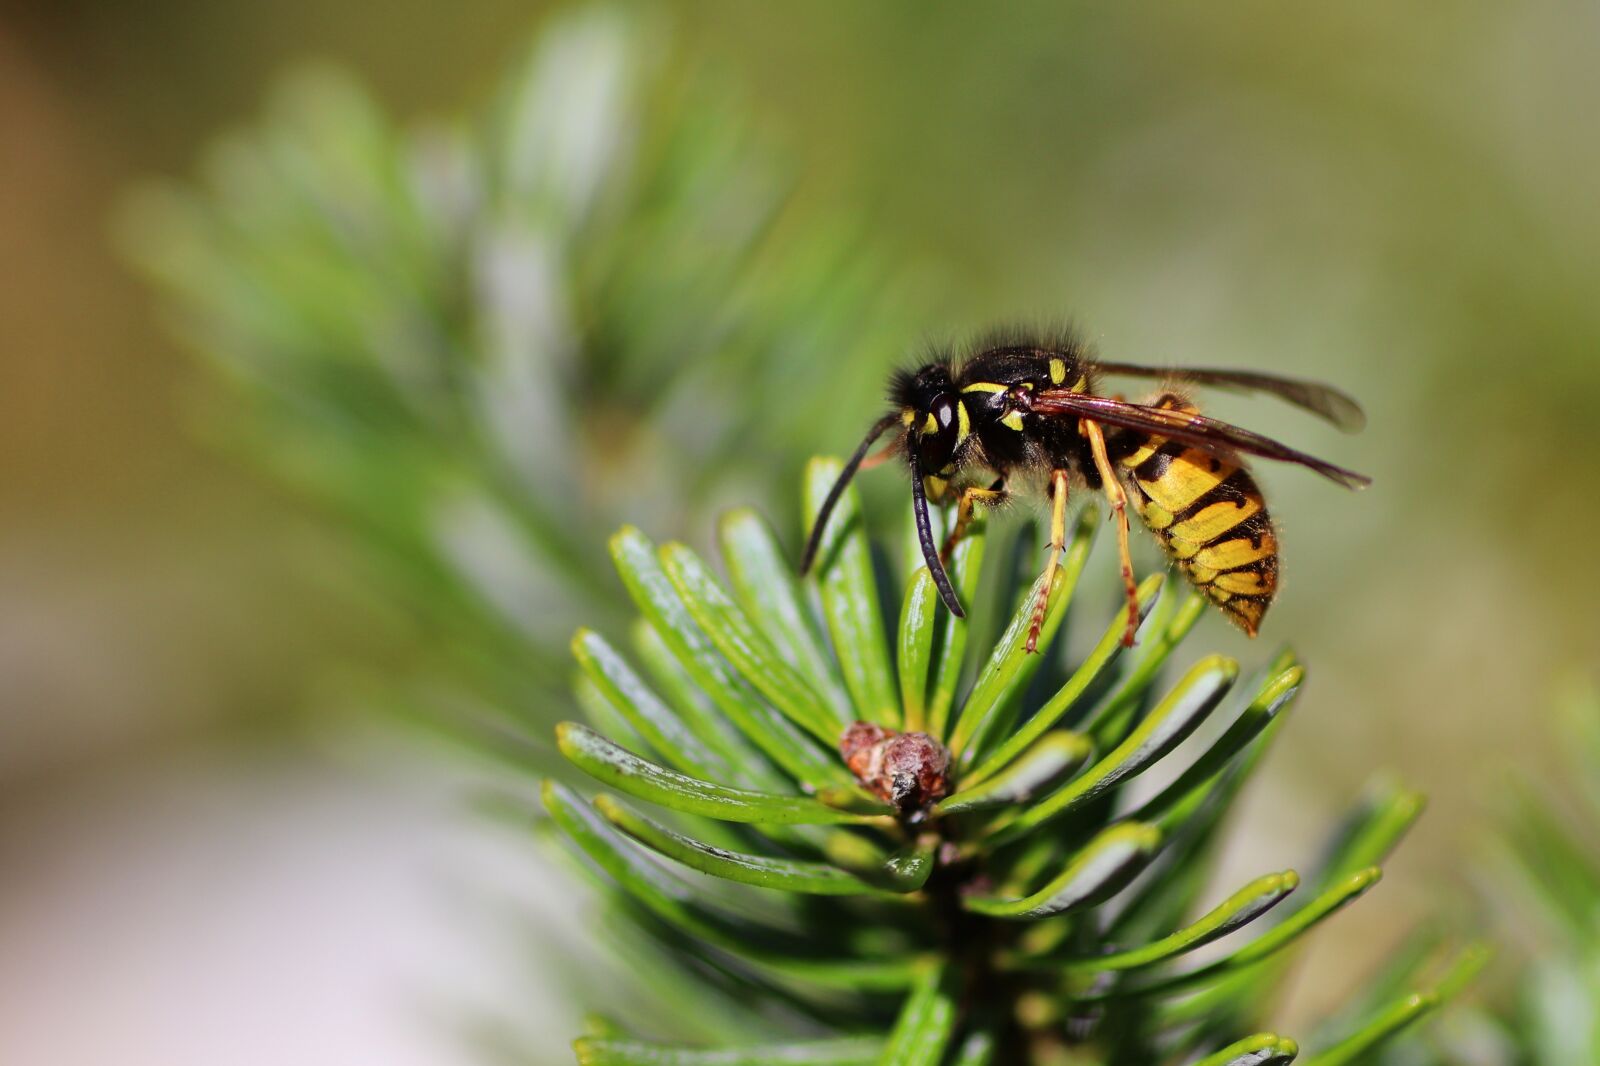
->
left=800, top=335, right=1371, bottom=651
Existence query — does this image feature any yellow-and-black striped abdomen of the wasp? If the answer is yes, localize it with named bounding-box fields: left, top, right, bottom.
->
left=1120, top=397, right=1278, bottom=637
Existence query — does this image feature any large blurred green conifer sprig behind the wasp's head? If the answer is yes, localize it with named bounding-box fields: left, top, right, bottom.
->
left=125, top=10, right=906, bottom=754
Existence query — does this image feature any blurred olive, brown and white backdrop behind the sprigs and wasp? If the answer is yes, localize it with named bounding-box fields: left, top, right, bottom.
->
left=0, top=0, right=1600, bottom=1066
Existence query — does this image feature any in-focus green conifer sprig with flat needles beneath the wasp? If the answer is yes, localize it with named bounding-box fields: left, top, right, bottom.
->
left=544, top=461, right=1483, bottom=1066
